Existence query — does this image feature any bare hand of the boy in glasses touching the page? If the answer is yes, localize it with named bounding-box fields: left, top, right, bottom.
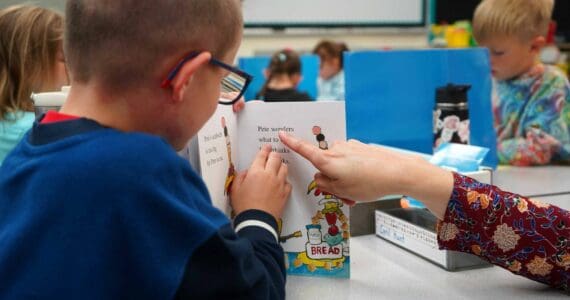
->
left=230, top=145, right=291, bottom=219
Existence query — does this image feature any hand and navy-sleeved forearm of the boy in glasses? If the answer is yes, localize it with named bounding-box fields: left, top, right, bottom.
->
left=177, top=145, right=291, bottom=299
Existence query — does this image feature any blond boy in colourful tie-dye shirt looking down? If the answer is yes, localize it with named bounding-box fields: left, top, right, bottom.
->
left=473, top=0, right=570, bottom=166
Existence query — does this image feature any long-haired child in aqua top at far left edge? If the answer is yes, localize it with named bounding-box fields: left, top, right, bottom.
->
left=0, top=5, right=68, bottom=165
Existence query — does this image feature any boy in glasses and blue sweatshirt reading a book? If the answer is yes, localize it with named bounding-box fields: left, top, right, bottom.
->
left=0, top=0, right=291, bottom=299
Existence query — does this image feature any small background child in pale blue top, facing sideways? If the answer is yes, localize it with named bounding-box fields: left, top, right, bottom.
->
left=313, top=40, right=348, bottom=101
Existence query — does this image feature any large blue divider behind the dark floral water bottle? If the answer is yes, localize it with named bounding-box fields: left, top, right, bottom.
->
left=344, top=48, right=498, bottom=168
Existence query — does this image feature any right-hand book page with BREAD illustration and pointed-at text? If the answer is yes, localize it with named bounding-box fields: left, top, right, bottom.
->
left=234, top=101, right=350, bottom=278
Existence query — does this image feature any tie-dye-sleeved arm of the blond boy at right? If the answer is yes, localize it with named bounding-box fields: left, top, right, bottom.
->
left=497, top=90, right=570, bottom=166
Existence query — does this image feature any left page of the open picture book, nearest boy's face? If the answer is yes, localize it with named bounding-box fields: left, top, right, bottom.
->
left=197, top=105, right=238, bottom=217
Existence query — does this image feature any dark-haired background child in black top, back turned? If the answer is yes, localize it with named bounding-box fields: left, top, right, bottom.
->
left=256, top=49, right=313, bottom=102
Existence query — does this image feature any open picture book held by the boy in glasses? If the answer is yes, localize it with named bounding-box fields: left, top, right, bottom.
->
left=196, top=101, right=350, bottom=278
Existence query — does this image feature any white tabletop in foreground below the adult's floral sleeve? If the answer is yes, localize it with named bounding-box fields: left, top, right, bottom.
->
left=287, top=235, right=569, bottom=300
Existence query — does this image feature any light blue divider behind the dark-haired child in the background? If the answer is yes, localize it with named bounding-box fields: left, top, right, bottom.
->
left=234, top=55, right=319, bottom=101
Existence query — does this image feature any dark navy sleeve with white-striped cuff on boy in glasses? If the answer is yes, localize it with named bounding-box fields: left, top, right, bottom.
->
left=175, top=210, right=285, bottom=299
